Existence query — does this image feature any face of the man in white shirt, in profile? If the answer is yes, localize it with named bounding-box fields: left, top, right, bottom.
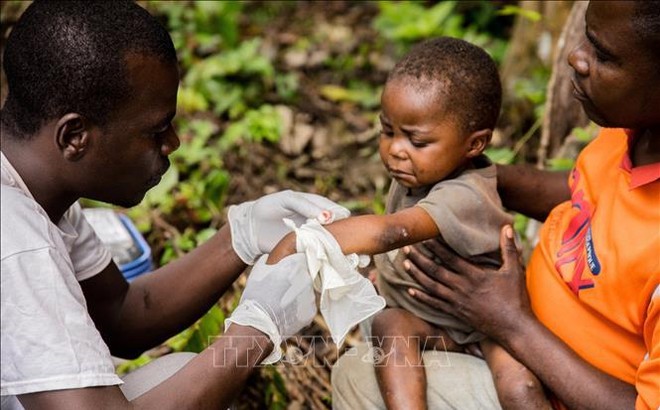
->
left=86, top=54, right=179, bottom=207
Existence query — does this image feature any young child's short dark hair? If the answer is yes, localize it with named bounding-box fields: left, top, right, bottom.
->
left=387, top=37, right=502, bottom=132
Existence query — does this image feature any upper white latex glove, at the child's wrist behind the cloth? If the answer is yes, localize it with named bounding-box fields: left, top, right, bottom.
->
left=228, top=190, right=351, bottom=265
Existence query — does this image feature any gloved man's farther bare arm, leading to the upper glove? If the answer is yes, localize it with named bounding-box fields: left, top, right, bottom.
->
left=80, top=225, right=246, bottom=358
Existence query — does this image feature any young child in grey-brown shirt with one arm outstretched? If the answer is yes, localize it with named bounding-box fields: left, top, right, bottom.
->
left=268, top=37, right=549, bottom=409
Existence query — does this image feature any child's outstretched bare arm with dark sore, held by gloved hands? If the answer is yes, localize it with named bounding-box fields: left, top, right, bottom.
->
left=267, top=206, right=440, bottom=264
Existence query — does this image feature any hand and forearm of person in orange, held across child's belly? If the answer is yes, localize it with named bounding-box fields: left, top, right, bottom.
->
left=404, top=227, right=636, bottom=409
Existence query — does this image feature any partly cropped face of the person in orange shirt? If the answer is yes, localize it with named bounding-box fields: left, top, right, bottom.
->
left=568, top=1, right=660, bottom=128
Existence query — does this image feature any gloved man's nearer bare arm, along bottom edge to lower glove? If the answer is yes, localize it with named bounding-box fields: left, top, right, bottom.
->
left=18, top=325, right=273, bottom=410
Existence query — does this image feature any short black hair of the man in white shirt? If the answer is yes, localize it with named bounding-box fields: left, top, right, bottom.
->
left=1, top=0, right=176, bottom=138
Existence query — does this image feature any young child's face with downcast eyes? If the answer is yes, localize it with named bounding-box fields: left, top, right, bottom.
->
left=380, top=79, right=468, bottom=188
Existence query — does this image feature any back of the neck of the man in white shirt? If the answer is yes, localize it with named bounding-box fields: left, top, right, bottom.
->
left=2, top=129, right=78, bottom=224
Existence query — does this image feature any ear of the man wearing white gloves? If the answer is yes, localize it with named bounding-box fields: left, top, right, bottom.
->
left=55, top=113, right=91, bottom=161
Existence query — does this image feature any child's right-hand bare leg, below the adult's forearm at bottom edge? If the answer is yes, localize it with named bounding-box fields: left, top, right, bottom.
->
left=480, top=339, right=552, bottom=410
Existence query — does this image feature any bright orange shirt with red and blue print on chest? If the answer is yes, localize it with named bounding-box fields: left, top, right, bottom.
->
left=527, top=129, right=660, bottom=410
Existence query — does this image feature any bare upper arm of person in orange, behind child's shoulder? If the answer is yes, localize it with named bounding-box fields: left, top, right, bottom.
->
left=497, top=165, right=571, bottom=221
